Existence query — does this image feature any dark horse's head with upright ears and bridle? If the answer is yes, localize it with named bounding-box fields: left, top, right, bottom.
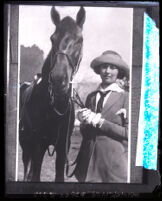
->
left=42, top=7, right=85, bottom=104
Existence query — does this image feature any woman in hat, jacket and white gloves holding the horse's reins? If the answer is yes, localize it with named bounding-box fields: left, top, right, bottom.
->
left=74, top=50, right=129, bottom=183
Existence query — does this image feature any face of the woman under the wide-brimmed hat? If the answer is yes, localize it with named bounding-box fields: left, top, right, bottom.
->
left=100, top=64, right=119, bottom=86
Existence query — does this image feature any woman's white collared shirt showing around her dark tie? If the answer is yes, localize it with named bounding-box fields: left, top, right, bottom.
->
left=95, top=83, right=124, bottom=111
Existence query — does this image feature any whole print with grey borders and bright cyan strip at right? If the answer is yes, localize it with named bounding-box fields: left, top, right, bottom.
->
left=6, top=1, right=159, bottom=196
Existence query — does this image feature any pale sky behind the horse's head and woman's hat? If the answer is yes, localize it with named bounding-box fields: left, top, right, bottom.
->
left=19, top=5, right=133, bottom=82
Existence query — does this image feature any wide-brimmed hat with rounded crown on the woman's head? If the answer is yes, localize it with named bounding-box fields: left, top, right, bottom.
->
left=90, top=50, right=129, bottom=76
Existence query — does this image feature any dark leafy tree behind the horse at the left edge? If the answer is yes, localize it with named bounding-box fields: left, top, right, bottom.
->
left=20, top=45, right=44, bottom=83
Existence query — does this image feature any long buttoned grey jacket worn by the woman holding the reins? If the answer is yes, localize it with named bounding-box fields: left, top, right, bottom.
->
left=74, top=91, right=129, bottom=183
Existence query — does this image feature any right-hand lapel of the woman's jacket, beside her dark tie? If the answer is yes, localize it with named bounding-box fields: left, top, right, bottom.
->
left=102, top=91, right=121, bottom=114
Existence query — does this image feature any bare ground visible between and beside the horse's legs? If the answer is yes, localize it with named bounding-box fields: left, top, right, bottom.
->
left=18, top=127, right=82, bottom=182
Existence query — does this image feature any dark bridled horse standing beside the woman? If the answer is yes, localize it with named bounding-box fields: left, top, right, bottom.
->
left=19, top=6, right=86, bottom=182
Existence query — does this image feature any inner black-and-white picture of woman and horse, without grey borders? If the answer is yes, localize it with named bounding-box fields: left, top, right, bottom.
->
left=17, top=6, right=133, bottom=183
